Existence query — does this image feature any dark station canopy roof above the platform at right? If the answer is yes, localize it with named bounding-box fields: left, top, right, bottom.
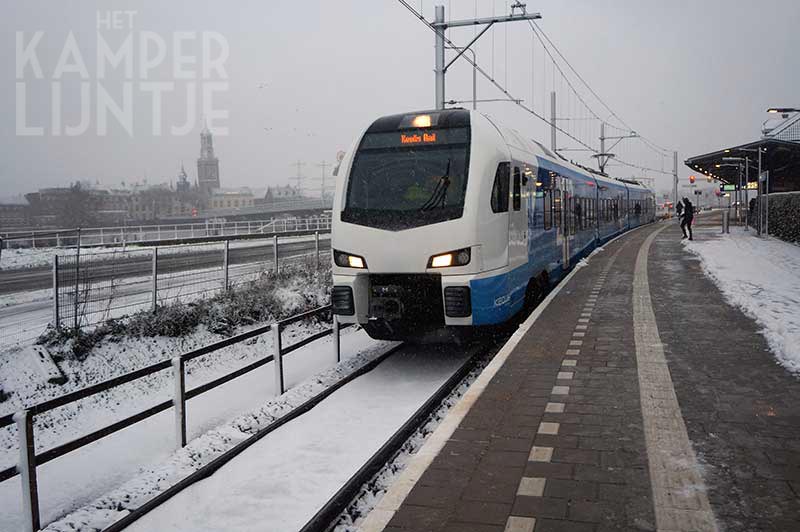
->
left=684, top=112, right=800, bottom=192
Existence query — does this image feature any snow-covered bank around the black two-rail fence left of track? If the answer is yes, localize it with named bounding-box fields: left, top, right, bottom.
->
left=0, top=326, right=391, bottom=531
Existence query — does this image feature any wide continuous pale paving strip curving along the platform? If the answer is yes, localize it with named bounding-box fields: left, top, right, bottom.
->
left=633, top=226, right=718, bottom=532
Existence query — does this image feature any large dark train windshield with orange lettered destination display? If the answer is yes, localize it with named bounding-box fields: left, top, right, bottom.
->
left=342, top=128, right=469, bottom=231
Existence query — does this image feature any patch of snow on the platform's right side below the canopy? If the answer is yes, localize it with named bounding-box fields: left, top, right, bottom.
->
left=684, top=227, right=800, bottom=374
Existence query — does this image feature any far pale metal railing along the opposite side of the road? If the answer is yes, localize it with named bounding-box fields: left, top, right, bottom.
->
left=0, top=216, right=331, bottom=250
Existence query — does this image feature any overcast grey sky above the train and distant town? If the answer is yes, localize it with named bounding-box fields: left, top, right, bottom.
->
left=0, top=0, right=800, bottom=200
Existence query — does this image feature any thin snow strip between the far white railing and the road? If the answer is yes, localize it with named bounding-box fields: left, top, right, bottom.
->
left=0, top=233, right=330, bottom=270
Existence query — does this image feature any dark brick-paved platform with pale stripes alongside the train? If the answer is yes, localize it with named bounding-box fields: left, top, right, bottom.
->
left=360, top=217, right=800, bottom=532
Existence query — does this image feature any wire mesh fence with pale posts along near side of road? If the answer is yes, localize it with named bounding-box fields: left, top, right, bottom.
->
left=0, top=233, right=330, bottom=346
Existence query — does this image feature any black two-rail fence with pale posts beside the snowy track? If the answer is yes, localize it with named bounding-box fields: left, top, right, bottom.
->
left=0, top=305, right=348, bottom=531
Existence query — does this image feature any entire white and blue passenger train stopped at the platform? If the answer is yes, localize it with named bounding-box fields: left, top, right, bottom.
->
left=331, top=109, right=655, bottom=340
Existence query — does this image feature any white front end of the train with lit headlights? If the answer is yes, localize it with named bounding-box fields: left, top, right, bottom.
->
left=331, top=110, right=500, bottom=340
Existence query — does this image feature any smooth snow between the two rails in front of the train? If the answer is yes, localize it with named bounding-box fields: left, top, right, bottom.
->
left=122, top=346, right=468, bottom=532
